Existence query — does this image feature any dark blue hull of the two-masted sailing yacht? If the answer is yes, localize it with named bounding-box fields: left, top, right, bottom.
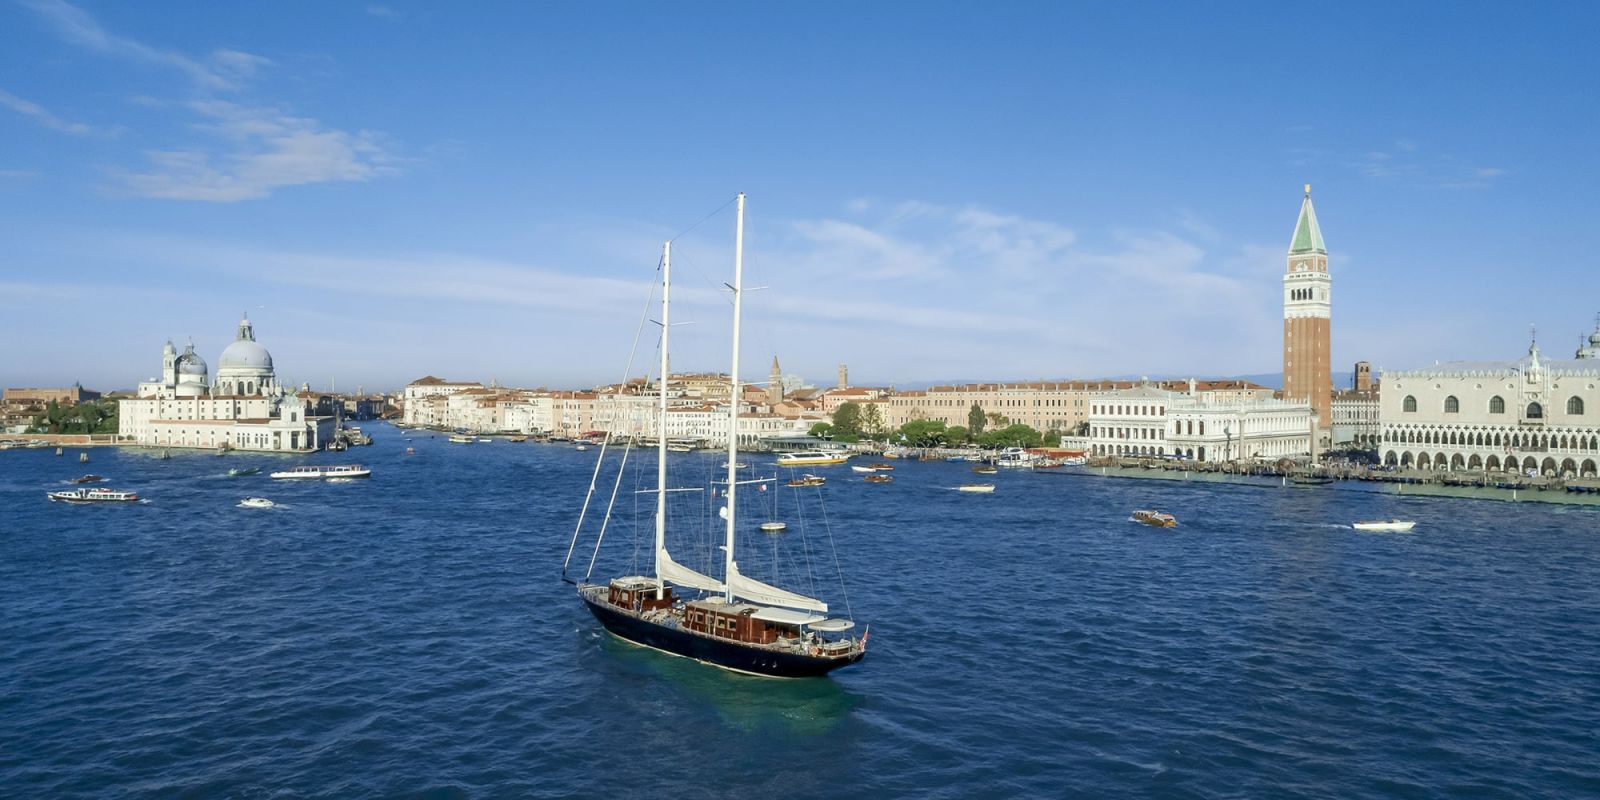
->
left=579, top=595, right=866, bottom=678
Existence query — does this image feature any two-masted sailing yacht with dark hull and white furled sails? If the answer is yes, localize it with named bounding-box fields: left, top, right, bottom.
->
left=563, top=194, right=867, bottom=678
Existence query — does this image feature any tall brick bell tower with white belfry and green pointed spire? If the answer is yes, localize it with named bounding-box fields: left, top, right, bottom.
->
left=1283, top=184, right=1333, bottom=450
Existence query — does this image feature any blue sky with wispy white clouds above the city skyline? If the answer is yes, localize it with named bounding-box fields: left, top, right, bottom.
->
left=0, top=0, right=1600, bottom=389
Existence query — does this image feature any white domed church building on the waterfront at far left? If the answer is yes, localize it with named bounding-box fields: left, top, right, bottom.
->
left=118, top=315, right=336, bottom=453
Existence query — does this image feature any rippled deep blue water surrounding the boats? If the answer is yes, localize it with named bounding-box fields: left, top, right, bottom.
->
left=0, top=426, right=1600, bottom=798
